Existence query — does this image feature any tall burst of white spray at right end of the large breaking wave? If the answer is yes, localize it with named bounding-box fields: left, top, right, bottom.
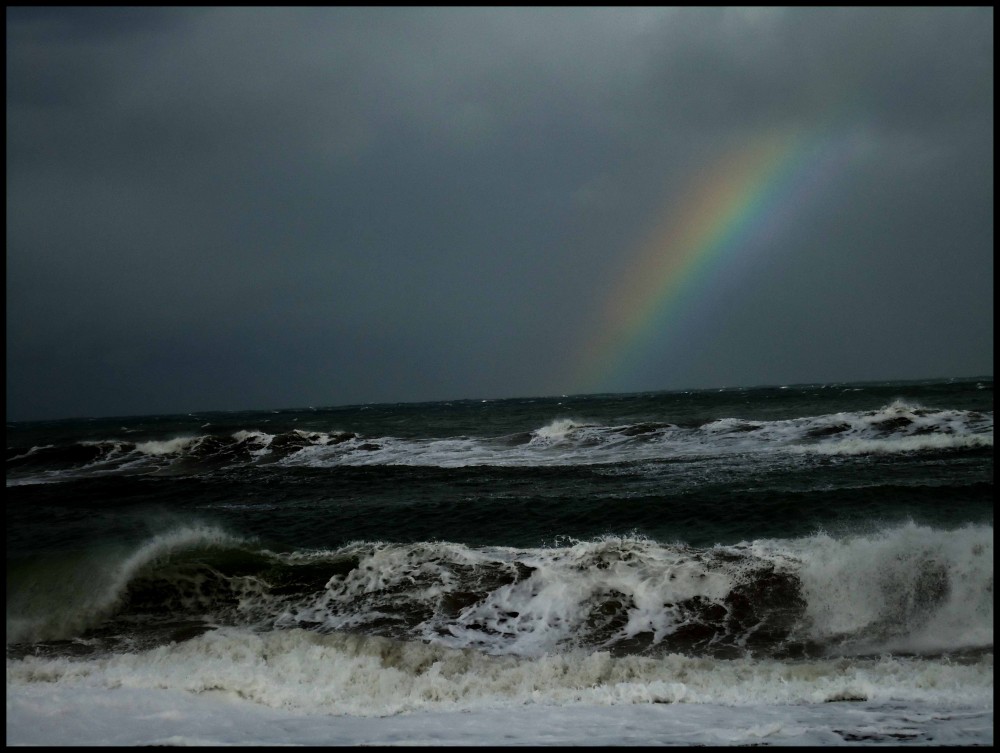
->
left=751, top=523, right=993, bottom=653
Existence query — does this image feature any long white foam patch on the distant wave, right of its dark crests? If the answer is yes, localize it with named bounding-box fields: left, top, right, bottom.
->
left=281, top=400, right=993, bottom=467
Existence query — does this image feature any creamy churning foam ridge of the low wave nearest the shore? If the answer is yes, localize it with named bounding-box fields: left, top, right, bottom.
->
left=7, top=628, right=993, bottom=716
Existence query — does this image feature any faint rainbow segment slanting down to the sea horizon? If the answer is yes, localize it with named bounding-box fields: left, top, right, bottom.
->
left=570, top=125, right=853, bottom=392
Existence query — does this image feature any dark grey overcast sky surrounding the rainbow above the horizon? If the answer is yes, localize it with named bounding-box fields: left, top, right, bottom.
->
left=7, top=8, right=993, bottom=420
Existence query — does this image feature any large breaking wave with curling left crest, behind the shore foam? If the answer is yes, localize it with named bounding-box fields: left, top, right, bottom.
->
left=7, top=523, right=993, bottom=658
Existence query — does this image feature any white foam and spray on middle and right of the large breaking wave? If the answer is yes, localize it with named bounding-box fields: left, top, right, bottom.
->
left=260, top=523, right=993, bottom=656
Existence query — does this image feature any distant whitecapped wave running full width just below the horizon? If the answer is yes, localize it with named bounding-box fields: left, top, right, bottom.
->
left=7, top=400, right=993, bottom=486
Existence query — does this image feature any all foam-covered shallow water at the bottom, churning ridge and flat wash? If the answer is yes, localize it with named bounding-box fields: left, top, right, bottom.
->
left=7, top=629, right=993, bottom=745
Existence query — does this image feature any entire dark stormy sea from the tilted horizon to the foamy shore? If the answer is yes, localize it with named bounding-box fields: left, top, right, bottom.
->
left=6, top=377, right=993, bottom=745
